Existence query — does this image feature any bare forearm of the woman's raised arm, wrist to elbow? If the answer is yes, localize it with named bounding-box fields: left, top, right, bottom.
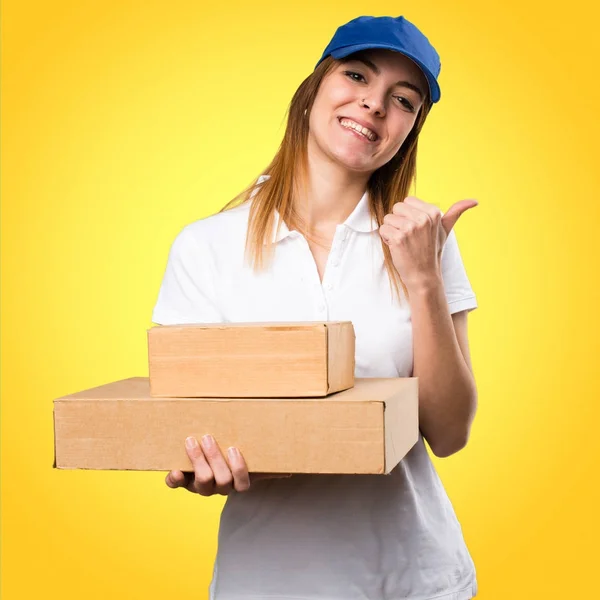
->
left=409, top=278, right=477, bottom=456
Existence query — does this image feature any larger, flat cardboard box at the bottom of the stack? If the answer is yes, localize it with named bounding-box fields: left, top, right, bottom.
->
left=54, top=377, right=418, bottom=473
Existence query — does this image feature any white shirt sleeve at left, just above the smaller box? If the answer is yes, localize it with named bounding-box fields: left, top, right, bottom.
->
left=152, top=226, right=224, bottom=325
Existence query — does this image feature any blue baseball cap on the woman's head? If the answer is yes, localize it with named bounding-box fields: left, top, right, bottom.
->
left=315, top=17, right=441, bottom=103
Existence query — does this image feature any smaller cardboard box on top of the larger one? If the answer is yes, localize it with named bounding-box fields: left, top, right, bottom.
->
left=148, top=321, right=355, bottom=398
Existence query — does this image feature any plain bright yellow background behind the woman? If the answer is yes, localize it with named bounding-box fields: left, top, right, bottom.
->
left=1, top=0, right=600, bottom=600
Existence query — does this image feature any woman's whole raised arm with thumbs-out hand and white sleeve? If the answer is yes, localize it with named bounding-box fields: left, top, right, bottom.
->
left=379, top=196, right=478, bottom=457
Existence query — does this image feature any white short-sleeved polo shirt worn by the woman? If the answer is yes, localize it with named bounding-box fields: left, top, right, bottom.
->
left=152, top=176, right=477, bottom=600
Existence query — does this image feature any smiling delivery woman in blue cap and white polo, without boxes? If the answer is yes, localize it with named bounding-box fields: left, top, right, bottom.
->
left=153, top=17, right=477, bottom=600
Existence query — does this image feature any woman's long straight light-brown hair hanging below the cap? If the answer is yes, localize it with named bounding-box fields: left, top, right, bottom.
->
left=221, top=56, right=431, bottom=296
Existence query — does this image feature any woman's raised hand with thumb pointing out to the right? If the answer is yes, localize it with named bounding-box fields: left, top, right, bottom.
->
left=379, top=196, right=478, bottom=291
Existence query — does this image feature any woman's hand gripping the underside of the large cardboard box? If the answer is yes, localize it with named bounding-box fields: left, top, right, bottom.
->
left=165, top=436, right=291, bottom=496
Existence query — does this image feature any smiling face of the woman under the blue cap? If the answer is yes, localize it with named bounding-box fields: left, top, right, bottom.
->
left=308, top=50, right=427, bottom=174
